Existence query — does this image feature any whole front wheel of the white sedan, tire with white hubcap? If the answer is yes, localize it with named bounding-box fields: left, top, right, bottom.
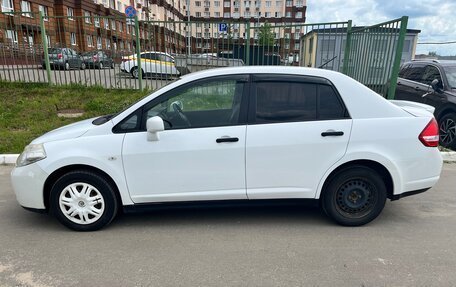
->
left=50, top=170, right=119, bottom=231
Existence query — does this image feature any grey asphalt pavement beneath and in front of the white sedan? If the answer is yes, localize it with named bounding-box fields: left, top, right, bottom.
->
left=0, top=164, right=456, bottom=286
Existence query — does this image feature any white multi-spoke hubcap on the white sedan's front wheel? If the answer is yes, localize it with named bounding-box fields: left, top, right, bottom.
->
left=59, top=182, right=105, bottom=225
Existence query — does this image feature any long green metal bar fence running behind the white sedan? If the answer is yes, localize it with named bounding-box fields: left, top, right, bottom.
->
left=0, top=12, right=406, bottom=95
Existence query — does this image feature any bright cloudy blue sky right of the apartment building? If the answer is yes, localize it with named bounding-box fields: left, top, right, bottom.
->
left=306, top=0, right=456, bottom=56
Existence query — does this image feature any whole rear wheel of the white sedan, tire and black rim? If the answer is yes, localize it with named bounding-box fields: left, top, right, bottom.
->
left=322, top=166, right=387, bottom=226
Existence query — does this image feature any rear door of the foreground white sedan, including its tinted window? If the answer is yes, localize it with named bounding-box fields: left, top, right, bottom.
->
left=246, top=76, right=352, bottom=199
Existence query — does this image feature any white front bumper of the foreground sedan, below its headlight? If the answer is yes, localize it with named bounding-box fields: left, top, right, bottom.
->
left=11, top=163, right=48, bottom=209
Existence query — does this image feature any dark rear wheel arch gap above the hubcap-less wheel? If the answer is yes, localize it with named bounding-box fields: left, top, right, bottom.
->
left=316, top=159, right=395, bottom=200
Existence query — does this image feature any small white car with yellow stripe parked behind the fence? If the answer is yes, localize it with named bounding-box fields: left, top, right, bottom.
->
left=120, top=52, right=180, bottom=79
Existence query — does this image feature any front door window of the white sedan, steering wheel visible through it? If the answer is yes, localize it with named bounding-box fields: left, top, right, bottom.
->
left=146, top=79, right=244, bottom=129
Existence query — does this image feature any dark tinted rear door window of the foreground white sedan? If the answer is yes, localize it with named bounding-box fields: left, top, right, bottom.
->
left=255, top=82, right=347, bottom=124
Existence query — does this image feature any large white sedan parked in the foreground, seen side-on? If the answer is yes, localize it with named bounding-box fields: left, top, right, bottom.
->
left=12, top=66, right=442, bottom=231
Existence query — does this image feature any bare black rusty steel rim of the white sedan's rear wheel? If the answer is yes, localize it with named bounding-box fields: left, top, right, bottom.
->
left=335, top=179, right=377, bottom=218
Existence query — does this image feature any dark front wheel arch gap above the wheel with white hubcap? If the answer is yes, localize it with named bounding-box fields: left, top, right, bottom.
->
left=43, top=164, right=123, bottom=211
